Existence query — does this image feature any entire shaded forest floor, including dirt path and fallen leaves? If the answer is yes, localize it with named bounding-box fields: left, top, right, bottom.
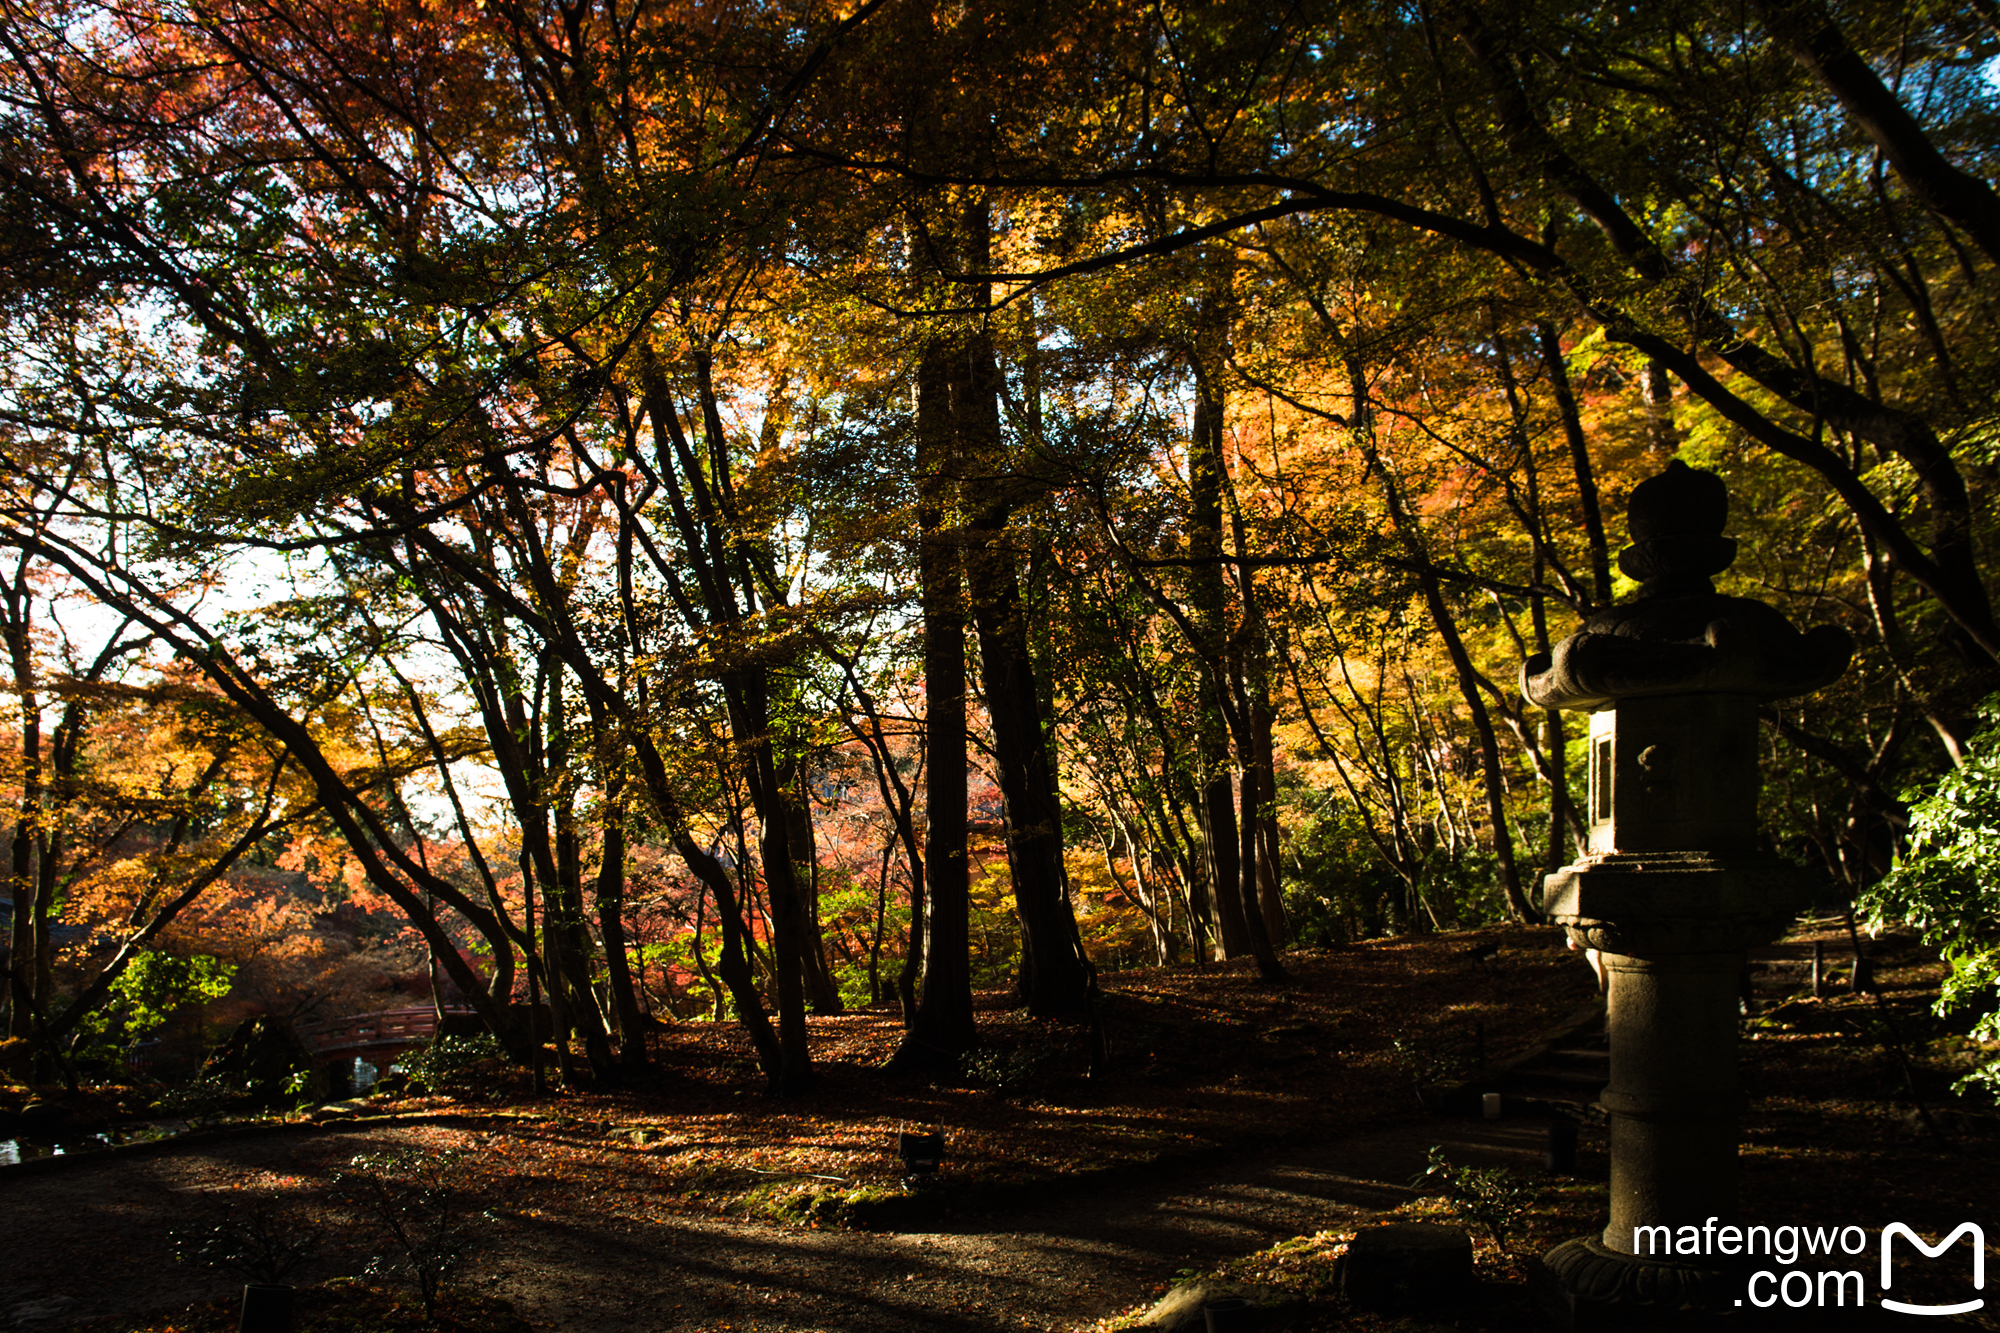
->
left=0, top=929, right=2000, bottom=1333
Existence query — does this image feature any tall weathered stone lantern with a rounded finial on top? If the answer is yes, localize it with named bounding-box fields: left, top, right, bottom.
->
left=1522, top=458, right=1852, bottom=1329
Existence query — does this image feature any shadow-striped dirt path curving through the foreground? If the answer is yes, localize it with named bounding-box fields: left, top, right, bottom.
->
left=0, top=1121, right=1542, bottom=1333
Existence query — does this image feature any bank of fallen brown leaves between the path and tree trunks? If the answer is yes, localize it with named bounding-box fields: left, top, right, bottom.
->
left=219, top=927, right=1592, bottom=1225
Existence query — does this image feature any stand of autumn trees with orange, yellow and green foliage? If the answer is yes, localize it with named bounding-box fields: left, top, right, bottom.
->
left=0, top=0, right=2000, bottom=1093
